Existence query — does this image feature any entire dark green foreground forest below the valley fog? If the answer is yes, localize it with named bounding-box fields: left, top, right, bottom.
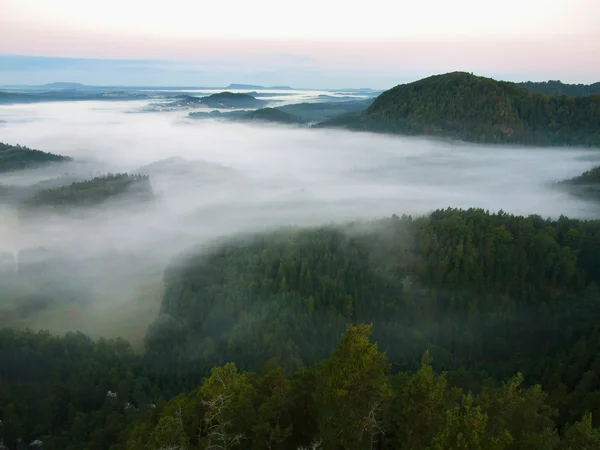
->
left=0, top=209, right=600, bottom=450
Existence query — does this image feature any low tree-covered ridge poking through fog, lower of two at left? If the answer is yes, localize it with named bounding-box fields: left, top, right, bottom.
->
left=25, top=173, right=152, bottom=207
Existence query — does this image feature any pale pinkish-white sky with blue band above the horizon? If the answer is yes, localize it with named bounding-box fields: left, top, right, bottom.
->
left=0, top=0, right=600, bottom=88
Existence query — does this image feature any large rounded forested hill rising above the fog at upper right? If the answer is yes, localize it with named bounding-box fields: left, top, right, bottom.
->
left=319, top=72, right=600, bottom=146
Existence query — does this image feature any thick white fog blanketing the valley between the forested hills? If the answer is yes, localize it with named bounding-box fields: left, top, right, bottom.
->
left=0, top=101, right=600, bottom=340
